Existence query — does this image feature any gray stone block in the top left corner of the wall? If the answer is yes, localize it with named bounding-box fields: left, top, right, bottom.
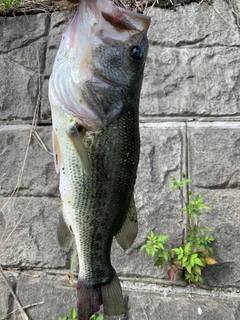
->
left=0, top=14, right=50, bottom=120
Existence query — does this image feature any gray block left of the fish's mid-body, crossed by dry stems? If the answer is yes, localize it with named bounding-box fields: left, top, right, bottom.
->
left=0, top=125, right=59, bottom=197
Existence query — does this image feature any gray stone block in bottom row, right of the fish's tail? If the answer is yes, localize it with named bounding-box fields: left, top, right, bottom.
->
left=125, top=291, right=240, bottom=320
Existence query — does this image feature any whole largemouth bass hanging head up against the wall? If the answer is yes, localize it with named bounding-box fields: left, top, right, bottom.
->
left=48, top=0, right=150, bottom=320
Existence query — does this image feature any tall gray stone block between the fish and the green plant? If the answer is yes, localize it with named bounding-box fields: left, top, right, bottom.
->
left=112, top=124, right=185, bottom=278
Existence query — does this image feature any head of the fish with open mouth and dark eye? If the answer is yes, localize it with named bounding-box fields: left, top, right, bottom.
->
left=49, top=0, right=150, bottom=129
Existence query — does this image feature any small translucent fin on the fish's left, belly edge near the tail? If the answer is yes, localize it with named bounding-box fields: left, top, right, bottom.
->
left=57, top=212, right=74, bottom=252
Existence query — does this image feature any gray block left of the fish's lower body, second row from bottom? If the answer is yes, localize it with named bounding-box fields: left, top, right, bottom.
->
left=0, top=197, right=67, bottom=269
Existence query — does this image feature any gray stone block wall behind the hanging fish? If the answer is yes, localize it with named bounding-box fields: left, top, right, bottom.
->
left=0, top=0, right=240, bottom=320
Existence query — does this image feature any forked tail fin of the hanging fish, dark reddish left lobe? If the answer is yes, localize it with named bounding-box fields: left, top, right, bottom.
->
left=77, top=271, right=125, bottom=320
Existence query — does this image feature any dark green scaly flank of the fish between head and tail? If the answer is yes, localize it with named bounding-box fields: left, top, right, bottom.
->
left=72, top=110, right=139, bottom=286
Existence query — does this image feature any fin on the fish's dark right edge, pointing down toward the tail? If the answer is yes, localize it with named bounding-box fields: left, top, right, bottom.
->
left=115, top=194, right=138, bottom=250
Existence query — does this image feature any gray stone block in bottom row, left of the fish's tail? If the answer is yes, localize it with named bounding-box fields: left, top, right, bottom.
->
left=0, top=272, right=76, bottom=320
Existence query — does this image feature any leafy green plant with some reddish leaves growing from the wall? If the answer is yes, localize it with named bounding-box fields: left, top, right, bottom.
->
left=140, top=174, right=216, bottom=285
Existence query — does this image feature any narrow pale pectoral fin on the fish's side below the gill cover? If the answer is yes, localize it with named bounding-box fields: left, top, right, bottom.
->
left=66, top=123, right=92, bottom=174
